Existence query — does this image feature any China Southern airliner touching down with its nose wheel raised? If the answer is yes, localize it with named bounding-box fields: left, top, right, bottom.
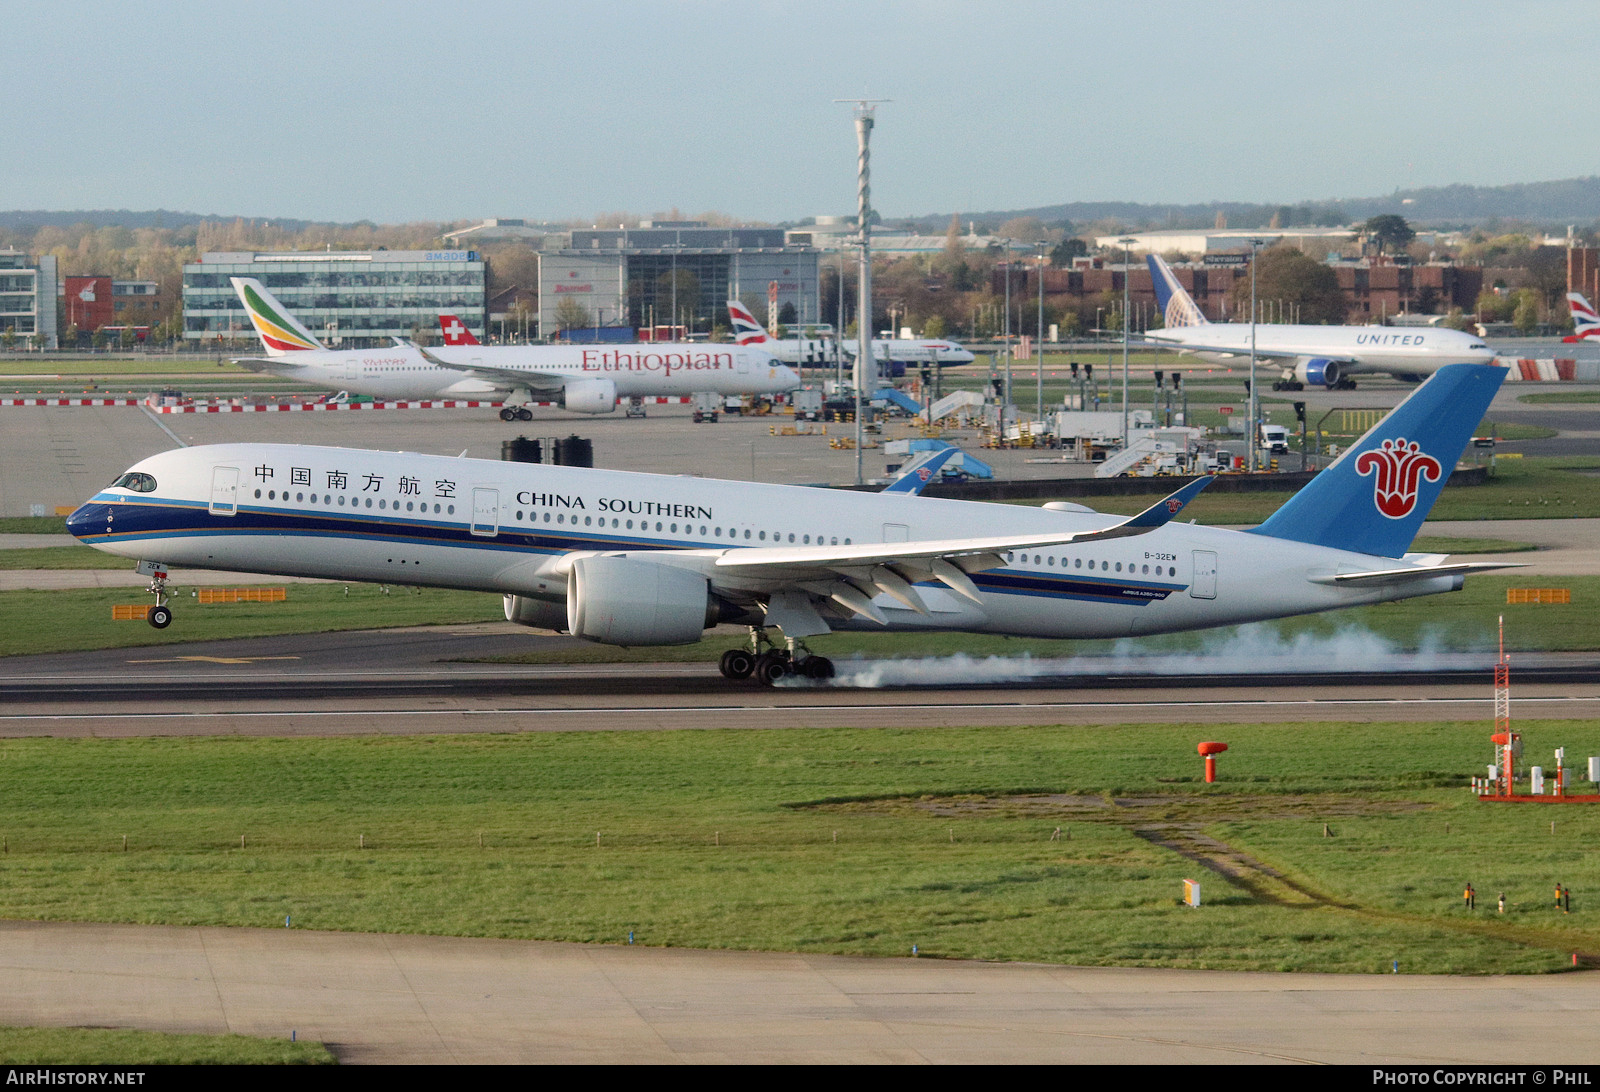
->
left=67, top=365, right=1506, bottom=682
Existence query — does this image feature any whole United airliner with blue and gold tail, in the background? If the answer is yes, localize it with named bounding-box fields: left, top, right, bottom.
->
left=1141, top=255, right=1494, bottom=391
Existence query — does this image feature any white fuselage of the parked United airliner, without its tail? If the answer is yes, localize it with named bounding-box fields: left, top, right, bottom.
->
left=1142, top=322, right=1494, bottom=375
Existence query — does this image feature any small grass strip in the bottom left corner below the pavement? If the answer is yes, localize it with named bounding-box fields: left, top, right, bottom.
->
left=0, top=1028, right=334, bottom=1068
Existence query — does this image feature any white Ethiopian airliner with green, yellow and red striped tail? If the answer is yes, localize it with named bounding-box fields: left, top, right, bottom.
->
left=232, top=277, right=800, bottom=421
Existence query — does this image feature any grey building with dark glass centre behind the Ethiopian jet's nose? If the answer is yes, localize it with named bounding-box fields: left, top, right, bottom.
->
left=539, top=221, right=826, bottom=339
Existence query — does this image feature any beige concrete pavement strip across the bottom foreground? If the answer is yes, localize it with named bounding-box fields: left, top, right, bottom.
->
left=0, top=922, right=1600, bottom=1065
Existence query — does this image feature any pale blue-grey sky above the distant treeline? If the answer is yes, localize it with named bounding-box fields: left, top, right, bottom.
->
left=9, top=0, right=1600, bottom=223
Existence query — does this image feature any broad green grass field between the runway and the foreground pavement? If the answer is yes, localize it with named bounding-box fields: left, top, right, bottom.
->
left=0, top=721, right=1600, bottom=974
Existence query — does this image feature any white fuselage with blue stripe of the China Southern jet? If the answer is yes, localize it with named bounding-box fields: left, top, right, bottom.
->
left=67, top=444, right=1461, bottom=637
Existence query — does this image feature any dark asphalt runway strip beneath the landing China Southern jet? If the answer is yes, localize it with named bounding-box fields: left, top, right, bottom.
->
left=0, top=624, right=1600, bottom=738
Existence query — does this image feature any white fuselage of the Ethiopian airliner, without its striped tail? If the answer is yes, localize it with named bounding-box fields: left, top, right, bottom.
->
left=241, top=344, right=800, bottom=399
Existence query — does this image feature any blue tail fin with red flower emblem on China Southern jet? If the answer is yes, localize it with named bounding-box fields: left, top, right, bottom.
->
left=1253, top=363, right=1506, bottom=557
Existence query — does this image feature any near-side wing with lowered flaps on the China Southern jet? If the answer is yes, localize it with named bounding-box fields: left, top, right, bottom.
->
left=611, top=477, right=1213, bottom=624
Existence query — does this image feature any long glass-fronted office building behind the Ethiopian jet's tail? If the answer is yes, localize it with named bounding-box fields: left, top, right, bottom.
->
left=184, top=250, right=486, bottom=346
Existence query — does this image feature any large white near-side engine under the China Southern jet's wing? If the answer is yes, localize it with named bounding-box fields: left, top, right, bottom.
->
left=566, top=557, right=715, bottom=645
